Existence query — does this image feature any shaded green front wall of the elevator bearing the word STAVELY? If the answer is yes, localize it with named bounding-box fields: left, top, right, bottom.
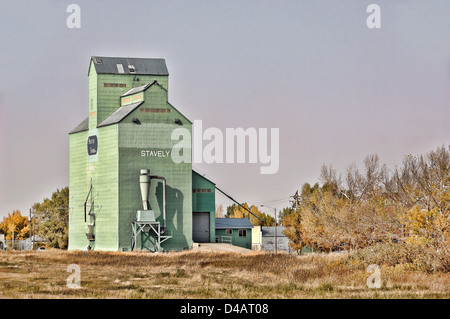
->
left=119, top=123, right=192, bottom=250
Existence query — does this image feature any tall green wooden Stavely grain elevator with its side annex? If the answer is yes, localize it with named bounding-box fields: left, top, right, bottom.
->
left=69, top=57, right=215, bottom=251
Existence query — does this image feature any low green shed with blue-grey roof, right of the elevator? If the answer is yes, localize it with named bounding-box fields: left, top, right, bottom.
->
left=216, top=218, right=253, bottom=249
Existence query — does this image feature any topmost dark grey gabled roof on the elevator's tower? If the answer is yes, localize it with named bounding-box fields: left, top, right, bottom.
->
left=91, top=56, right=169, bottom=75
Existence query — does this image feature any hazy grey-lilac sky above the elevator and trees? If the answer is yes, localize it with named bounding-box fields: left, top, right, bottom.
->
left=0, top=0, right=450, bottom=217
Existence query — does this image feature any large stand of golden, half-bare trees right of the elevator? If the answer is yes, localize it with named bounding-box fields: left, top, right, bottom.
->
left=282, top=146, right=450, bottom=262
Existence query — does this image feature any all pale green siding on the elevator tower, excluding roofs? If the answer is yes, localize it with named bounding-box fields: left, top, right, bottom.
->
left=69, top=61, right=192, bottom=251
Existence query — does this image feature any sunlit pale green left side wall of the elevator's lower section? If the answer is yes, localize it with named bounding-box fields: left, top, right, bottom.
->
left=69, top=126, right=118, bottom=250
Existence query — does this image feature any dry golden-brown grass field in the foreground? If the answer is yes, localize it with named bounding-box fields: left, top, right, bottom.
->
left=0, top=250, right=450, bottom=299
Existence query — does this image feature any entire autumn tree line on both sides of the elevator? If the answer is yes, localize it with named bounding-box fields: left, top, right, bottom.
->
left=0, top=146, right=450, bottom=259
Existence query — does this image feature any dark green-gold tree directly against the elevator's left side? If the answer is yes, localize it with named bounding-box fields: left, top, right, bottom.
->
left=32, top=187, right=69, bottom=248
